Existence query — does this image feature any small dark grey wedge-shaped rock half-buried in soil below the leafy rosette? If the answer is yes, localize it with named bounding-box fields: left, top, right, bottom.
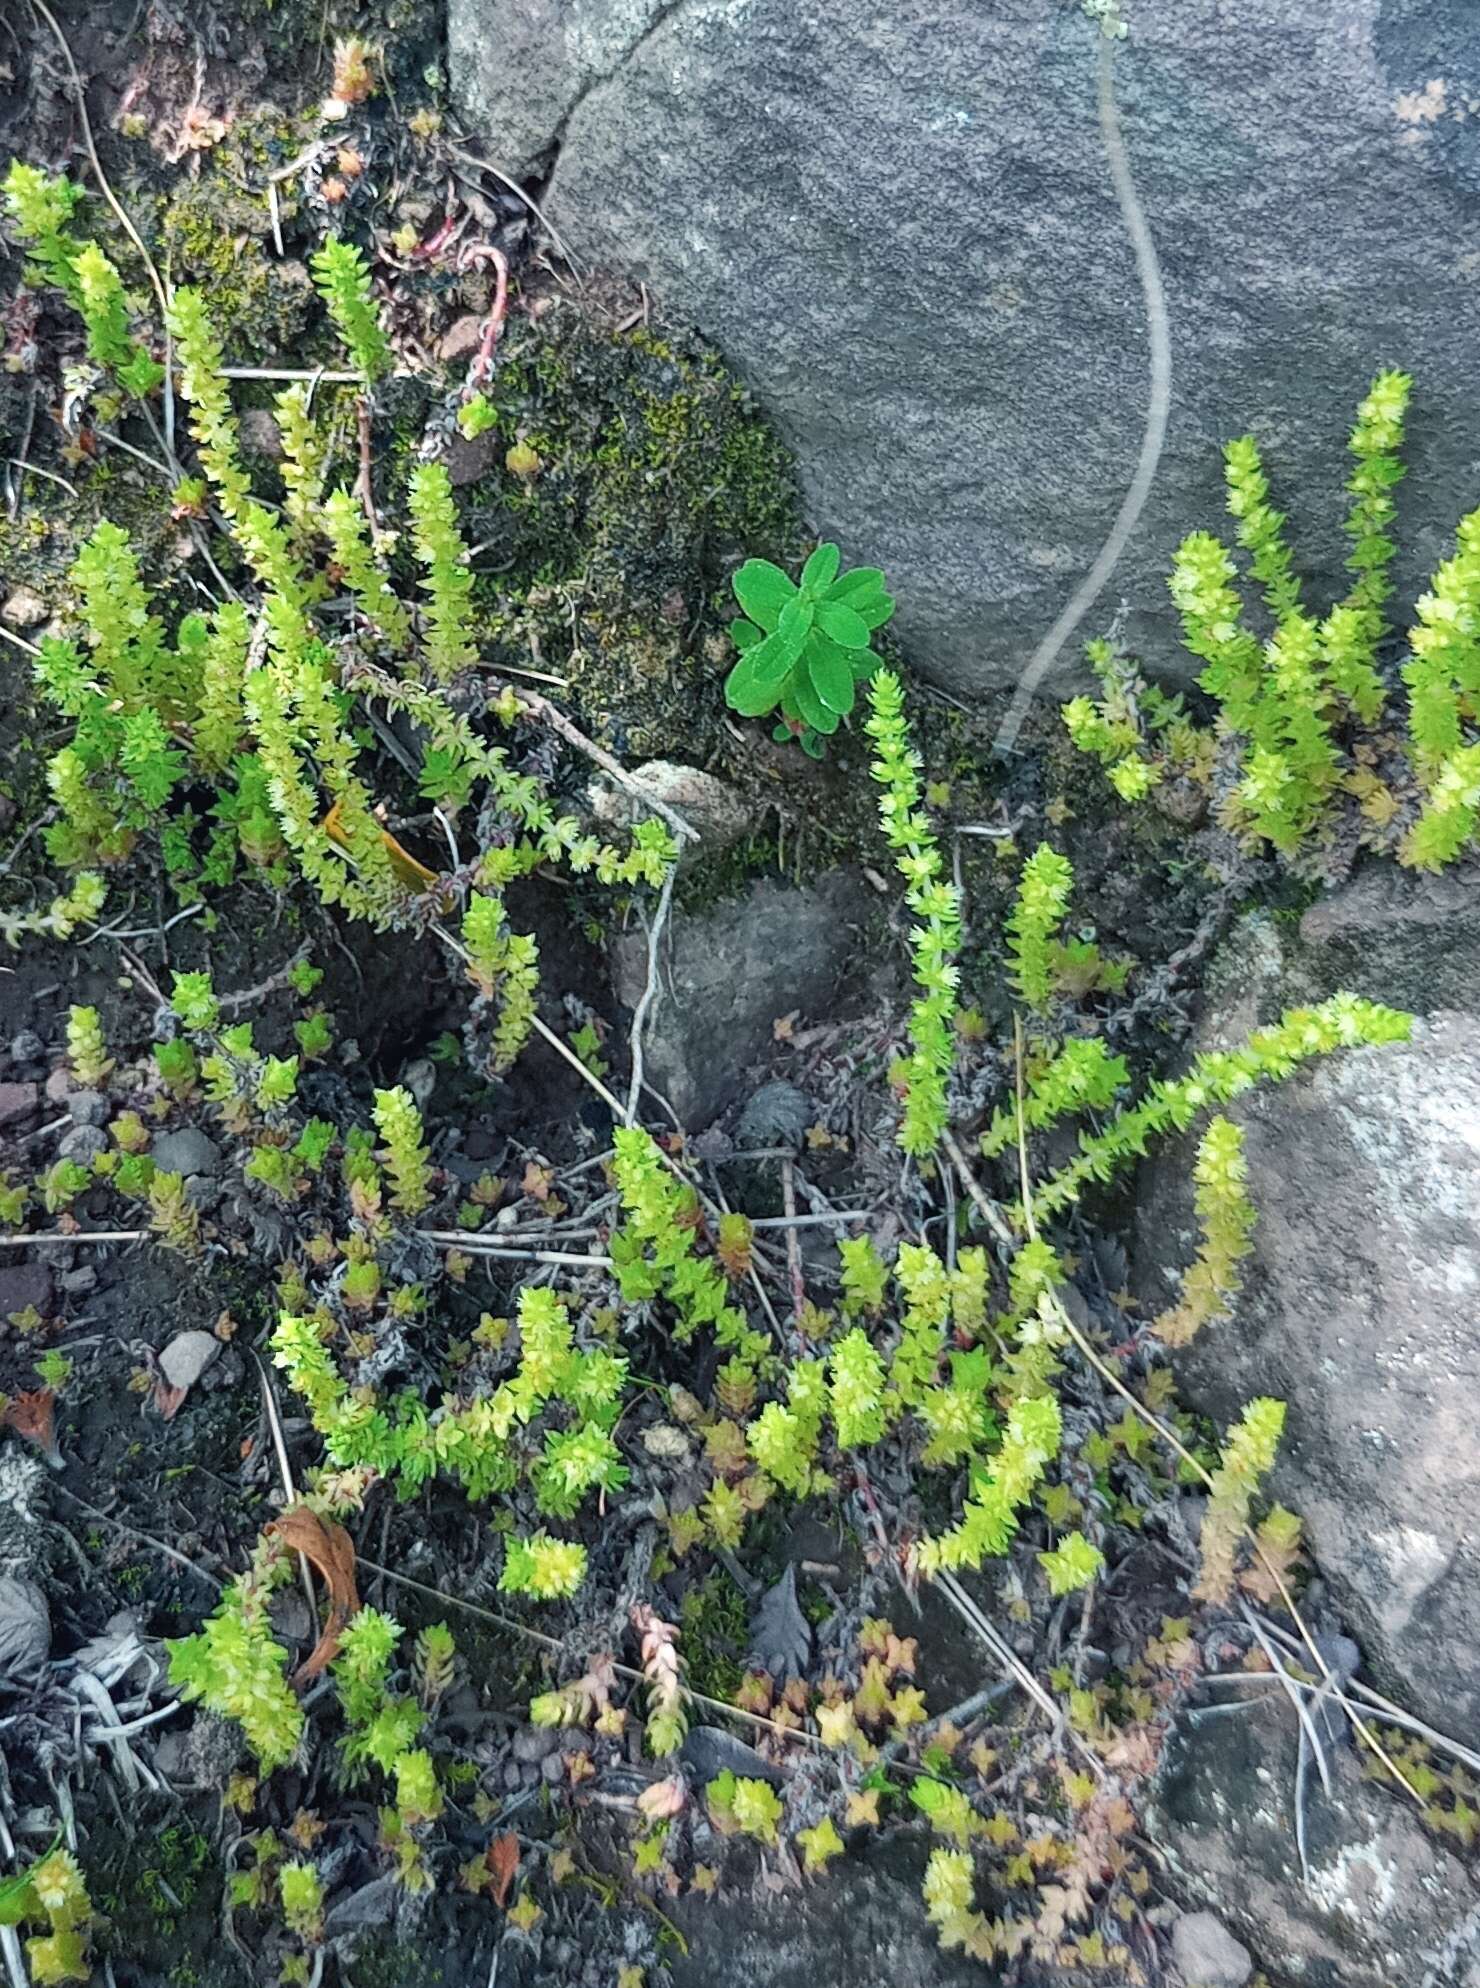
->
left=615, top=871, right=873, bottom=1131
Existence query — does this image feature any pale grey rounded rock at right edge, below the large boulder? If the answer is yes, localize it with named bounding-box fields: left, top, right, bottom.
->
left=1136, top=879, right=1480, bottom=1730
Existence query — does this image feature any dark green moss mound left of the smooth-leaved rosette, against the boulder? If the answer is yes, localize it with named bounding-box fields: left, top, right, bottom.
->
left=463, top=304, right=802, bottom=761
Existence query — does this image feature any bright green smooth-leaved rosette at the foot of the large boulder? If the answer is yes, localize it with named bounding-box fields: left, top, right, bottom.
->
left=724, top=545, right=895, bottom=759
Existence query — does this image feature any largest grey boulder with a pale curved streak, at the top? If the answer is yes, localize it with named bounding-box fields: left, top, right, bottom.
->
left=448, top=0, right=1480, bottom=688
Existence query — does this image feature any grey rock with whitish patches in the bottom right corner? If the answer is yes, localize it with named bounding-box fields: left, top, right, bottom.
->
left=1148, top=1686, right=1480, bottom=1988
